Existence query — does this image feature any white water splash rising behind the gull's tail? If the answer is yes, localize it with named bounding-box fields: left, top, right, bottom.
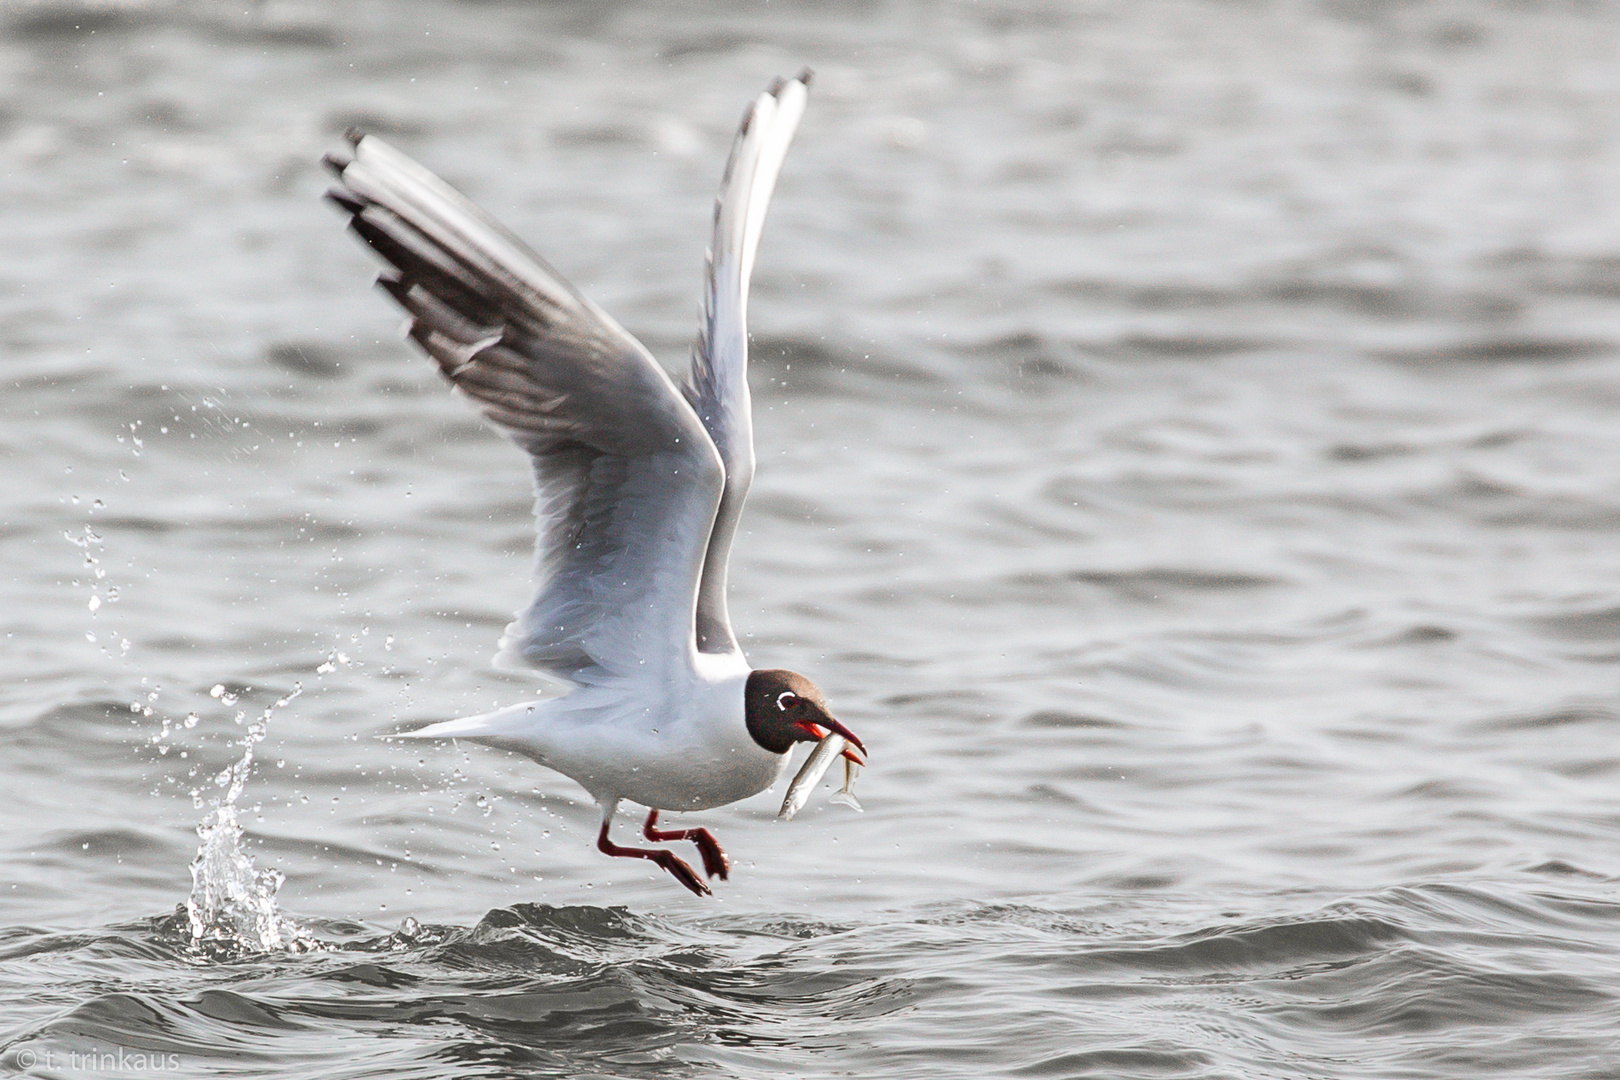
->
left=186, top=683, right=309, bottom=952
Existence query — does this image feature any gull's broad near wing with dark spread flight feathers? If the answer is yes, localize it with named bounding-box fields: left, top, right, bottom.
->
left=326, top=134, right=724, bottom=683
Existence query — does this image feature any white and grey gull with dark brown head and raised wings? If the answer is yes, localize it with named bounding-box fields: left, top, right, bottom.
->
left=322, top=68, right=865, bottom=895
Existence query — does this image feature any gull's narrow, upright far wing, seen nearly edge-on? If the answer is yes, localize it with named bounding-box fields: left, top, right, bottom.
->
left=682, top=68, right=810, bottom=653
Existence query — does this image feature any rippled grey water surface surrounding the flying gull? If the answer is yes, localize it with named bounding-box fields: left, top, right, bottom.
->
left=0, top=0, right=1620, bottom=1078
